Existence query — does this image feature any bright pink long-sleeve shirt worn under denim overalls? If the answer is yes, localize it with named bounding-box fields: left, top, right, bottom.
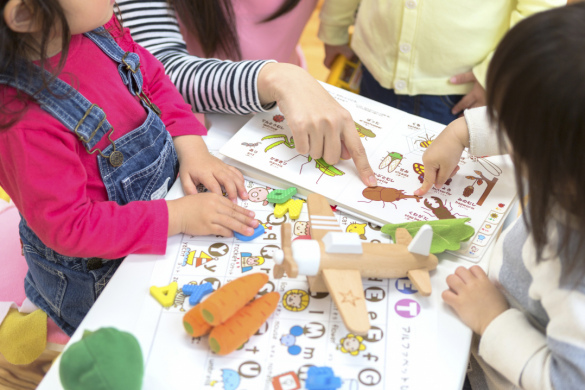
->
left=0, top=19, right=206, bottom=259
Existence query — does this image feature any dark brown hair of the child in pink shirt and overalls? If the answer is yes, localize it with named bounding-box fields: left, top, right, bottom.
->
left=0, top=0, right=71, bottom=130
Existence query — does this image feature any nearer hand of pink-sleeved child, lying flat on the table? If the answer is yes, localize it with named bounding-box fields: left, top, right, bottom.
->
left=167, top=192, right=258, bottom=237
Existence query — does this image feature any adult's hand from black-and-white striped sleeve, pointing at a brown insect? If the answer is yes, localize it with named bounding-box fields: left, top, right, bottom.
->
left=258, top=63, right=376, bottom=186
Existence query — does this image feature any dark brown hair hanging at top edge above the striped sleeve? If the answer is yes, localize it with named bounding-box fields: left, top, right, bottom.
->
left=168, top=0, right=300, bottom=60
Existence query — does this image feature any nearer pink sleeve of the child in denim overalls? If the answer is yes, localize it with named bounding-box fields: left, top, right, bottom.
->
left=0, top=125, right=168, bottom=259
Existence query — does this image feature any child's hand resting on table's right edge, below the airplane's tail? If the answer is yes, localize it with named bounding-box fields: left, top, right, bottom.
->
left=442, top=265, right=510, bottom=336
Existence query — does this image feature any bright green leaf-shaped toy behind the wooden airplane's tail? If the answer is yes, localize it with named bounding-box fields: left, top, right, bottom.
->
left=382, top=218, right=475, bottom=254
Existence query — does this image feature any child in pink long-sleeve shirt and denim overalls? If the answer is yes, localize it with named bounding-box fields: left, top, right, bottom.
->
left=0, top=0, right=258, bottom=335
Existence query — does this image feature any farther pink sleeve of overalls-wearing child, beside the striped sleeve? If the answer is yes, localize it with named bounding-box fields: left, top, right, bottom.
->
left=105, top=15, right=207, bottom=137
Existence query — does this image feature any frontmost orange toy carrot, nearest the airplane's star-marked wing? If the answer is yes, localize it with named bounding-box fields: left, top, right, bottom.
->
left=209, top=292, right=280, bottom=355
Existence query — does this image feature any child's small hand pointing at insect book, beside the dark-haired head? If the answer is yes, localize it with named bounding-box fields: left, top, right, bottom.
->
left=414, top=118, right=469, bottom=196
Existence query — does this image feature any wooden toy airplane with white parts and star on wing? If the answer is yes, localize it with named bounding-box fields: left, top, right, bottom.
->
left=273, top=194, right=438, bottom=335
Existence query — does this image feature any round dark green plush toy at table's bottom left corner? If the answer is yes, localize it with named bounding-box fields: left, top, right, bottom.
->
left=59, top=328, right=144, bottom=390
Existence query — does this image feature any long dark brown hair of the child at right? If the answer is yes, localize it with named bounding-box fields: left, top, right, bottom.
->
left=486, top=3, right=585, bottom=275
